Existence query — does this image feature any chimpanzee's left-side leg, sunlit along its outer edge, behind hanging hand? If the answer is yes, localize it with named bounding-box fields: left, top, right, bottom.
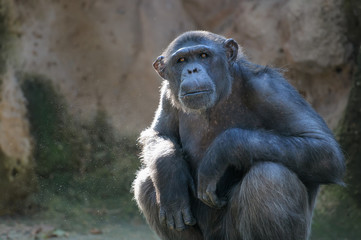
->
left=133, top=169, right=204, bottom=240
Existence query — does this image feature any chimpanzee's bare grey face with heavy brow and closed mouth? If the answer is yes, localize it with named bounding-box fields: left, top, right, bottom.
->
left=154, top=35, right=237, bottom=111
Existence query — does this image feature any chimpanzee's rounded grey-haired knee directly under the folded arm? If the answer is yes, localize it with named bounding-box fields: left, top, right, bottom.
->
left=231, top=162, right=311, bottom=240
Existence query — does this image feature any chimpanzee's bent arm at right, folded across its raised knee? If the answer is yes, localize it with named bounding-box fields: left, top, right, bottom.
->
left=198, top=70, right=345, bottom=206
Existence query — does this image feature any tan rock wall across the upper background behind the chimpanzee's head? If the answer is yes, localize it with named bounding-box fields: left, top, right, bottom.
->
left=0, top=0, right=354, bottom=213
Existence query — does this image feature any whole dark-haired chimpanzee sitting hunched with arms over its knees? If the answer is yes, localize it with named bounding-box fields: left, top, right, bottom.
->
left=133, top=31, right=345, bottom=240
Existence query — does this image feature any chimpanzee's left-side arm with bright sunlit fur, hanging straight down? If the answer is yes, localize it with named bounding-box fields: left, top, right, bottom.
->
left=139, top=85, right=196, bottom=230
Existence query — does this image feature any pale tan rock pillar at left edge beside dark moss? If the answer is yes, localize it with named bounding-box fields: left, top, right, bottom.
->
left=0, top=67, right=36, bottom=215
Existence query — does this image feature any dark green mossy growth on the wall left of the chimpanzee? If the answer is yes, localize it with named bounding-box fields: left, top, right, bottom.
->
left=20, top=74, right=139, bottom=229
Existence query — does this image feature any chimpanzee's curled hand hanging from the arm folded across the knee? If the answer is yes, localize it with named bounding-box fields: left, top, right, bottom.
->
left=197, top=146, right=227, bottom=208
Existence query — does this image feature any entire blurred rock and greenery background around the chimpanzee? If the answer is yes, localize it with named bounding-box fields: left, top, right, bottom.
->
left=0, top=0, right=361, bottom=240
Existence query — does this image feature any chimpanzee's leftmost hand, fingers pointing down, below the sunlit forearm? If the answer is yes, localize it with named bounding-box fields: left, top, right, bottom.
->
left=159, top=172, right=196, bottom=231
